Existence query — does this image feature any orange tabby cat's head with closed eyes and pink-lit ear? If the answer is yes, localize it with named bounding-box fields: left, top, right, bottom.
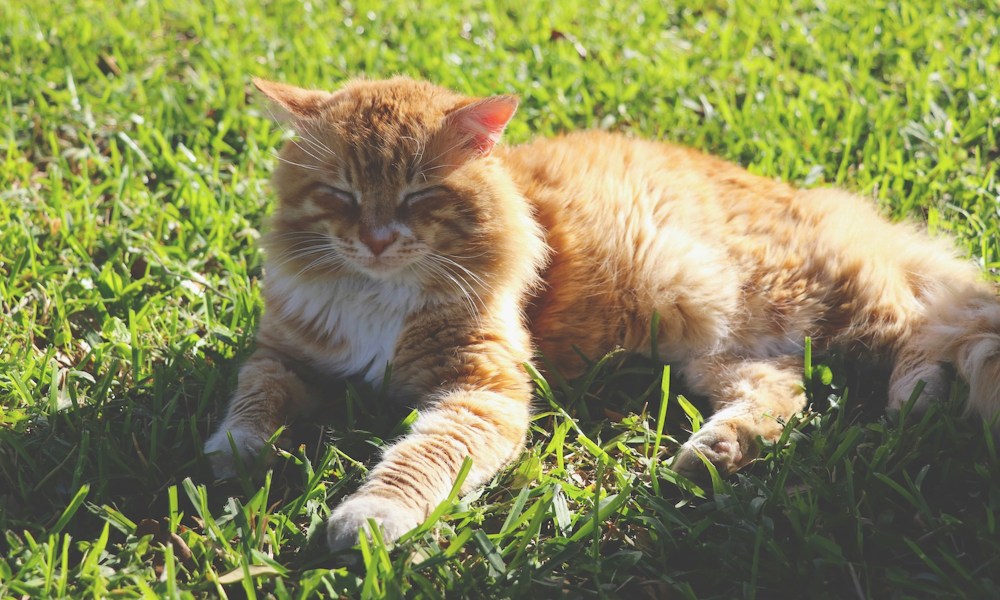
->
left=254, top=77, right=539, bottom=304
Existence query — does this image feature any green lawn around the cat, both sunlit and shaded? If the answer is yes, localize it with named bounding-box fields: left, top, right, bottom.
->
left=0, top=0, right=1000, bottom=598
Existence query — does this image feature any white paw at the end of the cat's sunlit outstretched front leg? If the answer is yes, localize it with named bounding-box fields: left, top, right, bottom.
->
left=326, top=495, right=424, bottom=551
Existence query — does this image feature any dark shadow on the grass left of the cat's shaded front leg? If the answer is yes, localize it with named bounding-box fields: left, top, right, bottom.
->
left=0, top=342, right=236, bottom=539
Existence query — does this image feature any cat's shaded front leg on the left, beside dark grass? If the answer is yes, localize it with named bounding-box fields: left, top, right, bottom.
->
left=204, top=348, right=308, bottom=479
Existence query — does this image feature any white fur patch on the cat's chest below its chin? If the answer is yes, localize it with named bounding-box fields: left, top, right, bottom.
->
left=266, top=273, right=426, bottom=383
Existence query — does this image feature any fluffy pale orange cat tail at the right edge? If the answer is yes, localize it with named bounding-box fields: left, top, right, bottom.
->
left=918, top=286, right=1000, bottom=431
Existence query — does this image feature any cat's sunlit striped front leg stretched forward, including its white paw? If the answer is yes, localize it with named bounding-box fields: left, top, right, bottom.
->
left=327, top=387, right=530, bottom=550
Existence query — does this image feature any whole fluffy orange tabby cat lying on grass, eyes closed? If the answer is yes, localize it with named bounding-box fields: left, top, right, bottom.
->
left=205, top=78, right=1000, bottom=548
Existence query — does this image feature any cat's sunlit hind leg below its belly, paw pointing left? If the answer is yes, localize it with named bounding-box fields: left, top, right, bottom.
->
left=673, top=356, right=806, bottom=476
